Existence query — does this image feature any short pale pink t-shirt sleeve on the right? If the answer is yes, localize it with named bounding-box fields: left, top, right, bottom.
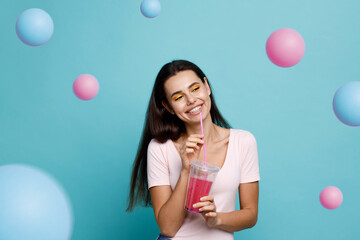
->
left=240, top=133, right=260, bottom=183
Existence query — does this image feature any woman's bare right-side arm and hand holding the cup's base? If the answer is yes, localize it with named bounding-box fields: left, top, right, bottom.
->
left=196, top=182, right=259, bottom=232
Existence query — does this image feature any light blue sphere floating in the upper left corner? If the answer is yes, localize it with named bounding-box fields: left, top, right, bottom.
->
left=16, top=8, right=54, bottom=46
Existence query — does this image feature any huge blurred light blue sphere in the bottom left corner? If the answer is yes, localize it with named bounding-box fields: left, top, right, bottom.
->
left=0, top=164, right=73, bottom=240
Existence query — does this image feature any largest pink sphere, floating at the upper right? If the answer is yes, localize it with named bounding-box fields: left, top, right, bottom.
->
left=266, top=28, right=305, bottom=67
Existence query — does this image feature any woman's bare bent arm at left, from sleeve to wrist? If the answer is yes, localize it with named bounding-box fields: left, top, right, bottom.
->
left=150, top=171, right=188, bottom=237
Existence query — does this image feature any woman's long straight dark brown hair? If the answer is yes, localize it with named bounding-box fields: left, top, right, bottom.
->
left=126, top=60, right=230, bottom=212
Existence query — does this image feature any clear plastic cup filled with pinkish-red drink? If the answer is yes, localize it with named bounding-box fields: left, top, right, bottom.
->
left=185, top=160, right=220, bottom=213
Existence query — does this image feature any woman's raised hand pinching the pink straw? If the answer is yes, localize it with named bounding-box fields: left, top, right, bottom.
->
left=180, top=134, right=204, bottom=171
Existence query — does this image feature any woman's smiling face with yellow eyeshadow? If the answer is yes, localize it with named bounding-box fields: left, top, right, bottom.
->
left=163, top=70, right=211, bottom=123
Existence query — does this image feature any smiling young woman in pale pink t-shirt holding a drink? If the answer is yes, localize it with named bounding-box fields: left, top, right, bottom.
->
left=127, top=60, right=260, bottom=240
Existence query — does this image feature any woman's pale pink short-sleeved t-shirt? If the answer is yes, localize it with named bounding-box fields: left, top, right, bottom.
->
left=147, top=129, right=260, bottom=240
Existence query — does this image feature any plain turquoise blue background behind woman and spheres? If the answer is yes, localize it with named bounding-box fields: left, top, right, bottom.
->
left=0, top=0, right=360, bottom=240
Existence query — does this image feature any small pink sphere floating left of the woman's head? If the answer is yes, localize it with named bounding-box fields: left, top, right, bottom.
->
left=73, top=74, right=99, bottom=100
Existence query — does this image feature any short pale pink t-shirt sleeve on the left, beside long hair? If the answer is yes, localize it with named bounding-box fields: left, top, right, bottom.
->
left=147, top=139, right=170, bottom=189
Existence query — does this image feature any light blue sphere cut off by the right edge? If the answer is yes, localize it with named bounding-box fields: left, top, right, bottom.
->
left=333, top=81, right=360, bottom=127
